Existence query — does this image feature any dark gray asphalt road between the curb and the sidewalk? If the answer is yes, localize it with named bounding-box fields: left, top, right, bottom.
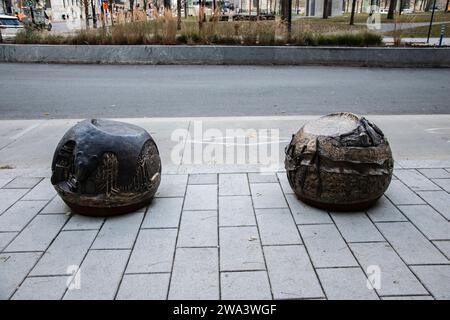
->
left=0, top=64, right=450, bottom=119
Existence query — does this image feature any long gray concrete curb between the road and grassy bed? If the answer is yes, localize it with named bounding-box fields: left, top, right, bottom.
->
left=0, top=44, right=450, bottom=68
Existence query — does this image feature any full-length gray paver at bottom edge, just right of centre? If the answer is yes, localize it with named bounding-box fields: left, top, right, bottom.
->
left=264, top=245, right=324, bottom=299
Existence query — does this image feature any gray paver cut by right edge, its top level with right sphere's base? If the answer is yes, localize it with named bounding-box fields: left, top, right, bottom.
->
left=399, top=205, right=450, bottom=240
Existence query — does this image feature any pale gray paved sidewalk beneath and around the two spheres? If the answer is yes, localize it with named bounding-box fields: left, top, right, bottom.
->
left=0, top=115, right=450, bottom=299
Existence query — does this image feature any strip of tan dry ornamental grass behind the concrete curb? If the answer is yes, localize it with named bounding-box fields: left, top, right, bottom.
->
left=15, top=11, right=381, bottom=46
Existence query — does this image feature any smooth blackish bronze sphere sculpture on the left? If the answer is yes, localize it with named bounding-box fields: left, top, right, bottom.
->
left=51, top=119, right=161, bottom=216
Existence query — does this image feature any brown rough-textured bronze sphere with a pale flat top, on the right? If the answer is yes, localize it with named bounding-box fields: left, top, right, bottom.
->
left=285, top=112, right=394, bottom=211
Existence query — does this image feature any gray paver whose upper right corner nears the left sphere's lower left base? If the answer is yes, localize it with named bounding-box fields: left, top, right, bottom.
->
left=5, top=215, right=67, bottom=251
